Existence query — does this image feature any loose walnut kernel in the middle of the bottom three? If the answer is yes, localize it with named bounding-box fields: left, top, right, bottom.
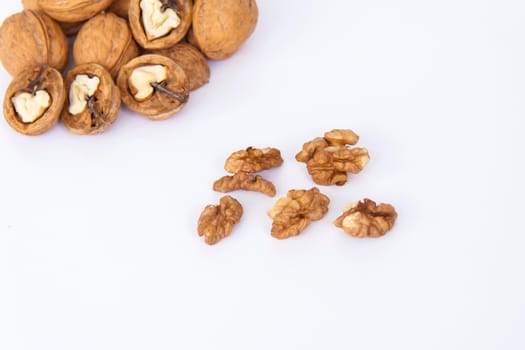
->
left=268, top=187, right=330, bottom=239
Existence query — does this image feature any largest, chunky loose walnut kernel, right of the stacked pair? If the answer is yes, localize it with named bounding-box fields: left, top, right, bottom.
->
left=295, top=129, right=370, bottom=186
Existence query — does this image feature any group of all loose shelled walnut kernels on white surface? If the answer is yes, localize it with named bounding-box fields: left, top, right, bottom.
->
left=198, top=129, right=397, bottom=244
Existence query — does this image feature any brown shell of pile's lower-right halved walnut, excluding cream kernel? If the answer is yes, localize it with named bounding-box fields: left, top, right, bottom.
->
left=117, top=55, right=190, bottom=120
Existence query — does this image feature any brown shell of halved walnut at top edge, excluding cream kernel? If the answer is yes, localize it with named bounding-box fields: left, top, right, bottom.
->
left=128, top=0, right=193, bottom=50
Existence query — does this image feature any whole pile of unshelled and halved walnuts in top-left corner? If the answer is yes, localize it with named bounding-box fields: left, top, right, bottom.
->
left=0, top=0, right=258, bottom=135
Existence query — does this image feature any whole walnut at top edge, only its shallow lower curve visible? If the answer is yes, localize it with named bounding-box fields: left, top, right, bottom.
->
left=38, top=0, right=112, bottom=23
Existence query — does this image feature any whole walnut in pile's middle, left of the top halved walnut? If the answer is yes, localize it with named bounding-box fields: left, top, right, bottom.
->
left=73, top=12, right=139, bottom=78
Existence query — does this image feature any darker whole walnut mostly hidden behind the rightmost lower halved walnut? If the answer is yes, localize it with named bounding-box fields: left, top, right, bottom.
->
left=152, top=43, right=210, bottom=90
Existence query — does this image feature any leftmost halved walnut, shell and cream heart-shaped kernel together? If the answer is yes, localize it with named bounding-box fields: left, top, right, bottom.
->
left=3, top=66, right=66, bottom=135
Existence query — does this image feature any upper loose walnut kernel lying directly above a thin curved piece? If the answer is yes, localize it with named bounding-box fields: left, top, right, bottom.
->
left=224, top=147, right=283, bottom=174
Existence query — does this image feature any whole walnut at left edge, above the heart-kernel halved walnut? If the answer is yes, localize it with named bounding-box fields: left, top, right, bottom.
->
left=0, top=10, right=68, bottom=76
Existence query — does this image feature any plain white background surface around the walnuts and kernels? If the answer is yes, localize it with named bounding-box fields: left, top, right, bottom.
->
left=0, top=0, right=525, bottom=350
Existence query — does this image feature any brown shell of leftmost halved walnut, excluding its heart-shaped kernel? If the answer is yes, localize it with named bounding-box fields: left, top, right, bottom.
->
left=4, top=66, right=66, bottom=135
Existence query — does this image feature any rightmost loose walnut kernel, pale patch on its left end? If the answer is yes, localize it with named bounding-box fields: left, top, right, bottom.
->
left=334, top=198, right=397, bottom=238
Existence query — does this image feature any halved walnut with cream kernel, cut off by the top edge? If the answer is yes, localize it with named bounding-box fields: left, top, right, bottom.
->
left=128, top=0, right=193, bottom=49
